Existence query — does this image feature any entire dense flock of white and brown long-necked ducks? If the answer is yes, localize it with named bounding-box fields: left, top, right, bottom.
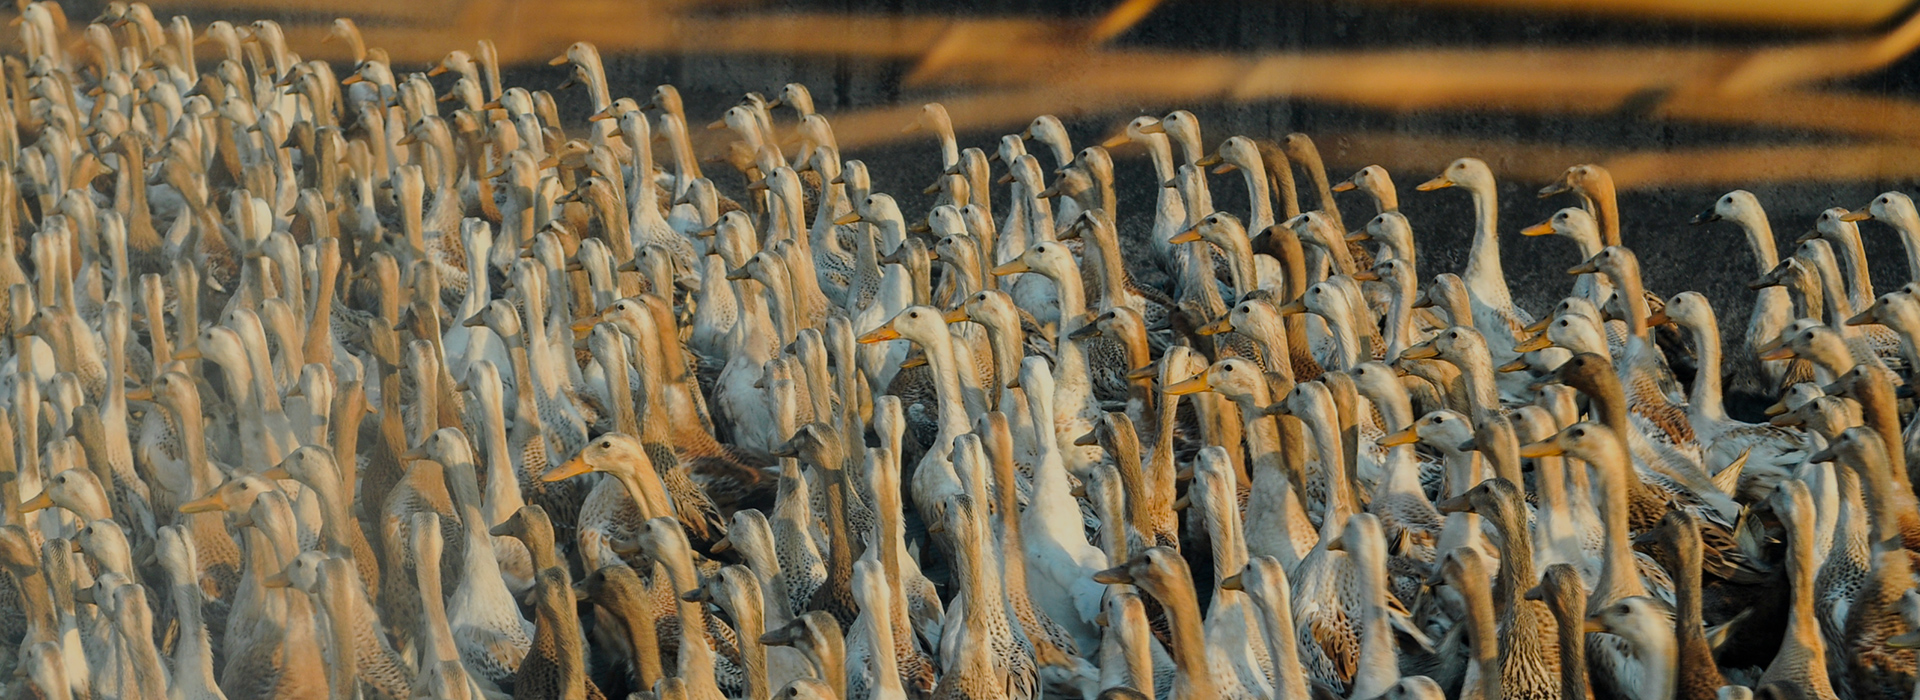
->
left=0, top=2, right=1920, bottom=700
